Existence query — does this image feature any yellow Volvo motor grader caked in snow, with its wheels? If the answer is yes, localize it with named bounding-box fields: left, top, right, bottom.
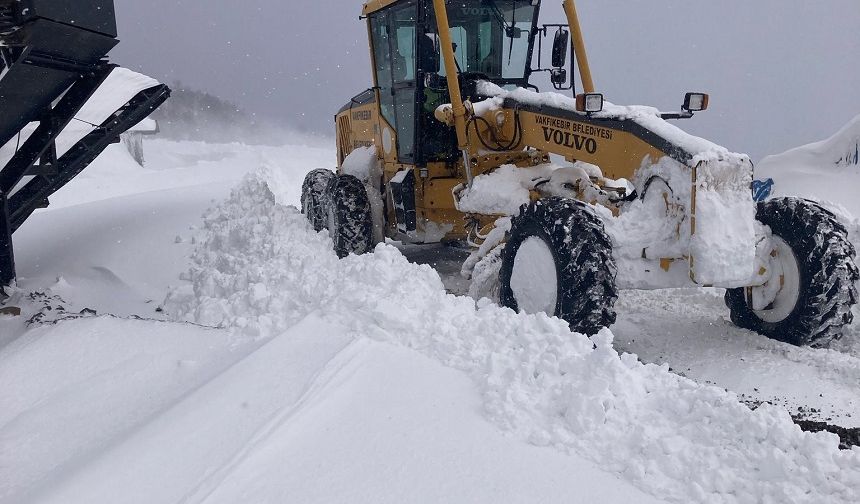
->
left=302, top=0, right=860, bottom=346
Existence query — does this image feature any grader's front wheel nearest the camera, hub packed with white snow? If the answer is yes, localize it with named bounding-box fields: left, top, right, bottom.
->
left=499, top=198, right=618, bottom=336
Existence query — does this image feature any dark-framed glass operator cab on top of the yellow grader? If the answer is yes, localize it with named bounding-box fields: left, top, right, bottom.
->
left=365, top=0, right=540, bottom=166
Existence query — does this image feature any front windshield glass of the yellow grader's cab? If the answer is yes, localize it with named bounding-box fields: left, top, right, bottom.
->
left=426, top=0, right=535, bottom=80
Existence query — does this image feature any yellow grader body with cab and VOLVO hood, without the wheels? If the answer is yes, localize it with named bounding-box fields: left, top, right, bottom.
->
left=336, top=0, right=754, bottom=286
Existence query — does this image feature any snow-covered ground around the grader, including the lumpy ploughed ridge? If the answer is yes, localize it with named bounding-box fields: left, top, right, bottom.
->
left=0, top=135, right=860, bottom=503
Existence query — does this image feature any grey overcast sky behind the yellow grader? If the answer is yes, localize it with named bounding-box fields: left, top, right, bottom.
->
left=112, top=0, right=860, bottom=160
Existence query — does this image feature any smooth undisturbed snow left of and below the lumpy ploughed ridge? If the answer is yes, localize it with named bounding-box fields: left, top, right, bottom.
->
left=0, top=140, right=658, bottom=504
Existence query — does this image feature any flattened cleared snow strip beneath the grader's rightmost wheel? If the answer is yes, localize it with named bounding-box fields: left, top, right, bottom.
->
left=612, top=289, right=860, bottom=427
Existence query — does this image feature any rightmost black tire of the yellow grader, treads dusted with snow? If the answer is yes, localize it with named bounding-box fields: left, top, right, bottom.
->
left=726, top=198, right=860, bottom=347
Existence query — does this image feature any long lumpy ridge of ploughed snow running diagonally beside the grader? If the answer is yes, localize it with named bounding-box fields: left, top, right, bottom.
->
left=166, top=169, right=860, bottom=503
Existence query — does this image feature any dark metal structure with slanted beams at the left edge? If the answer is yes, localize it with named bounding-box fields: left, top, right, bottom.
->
left=0, top=0, right=170, bottom=286
